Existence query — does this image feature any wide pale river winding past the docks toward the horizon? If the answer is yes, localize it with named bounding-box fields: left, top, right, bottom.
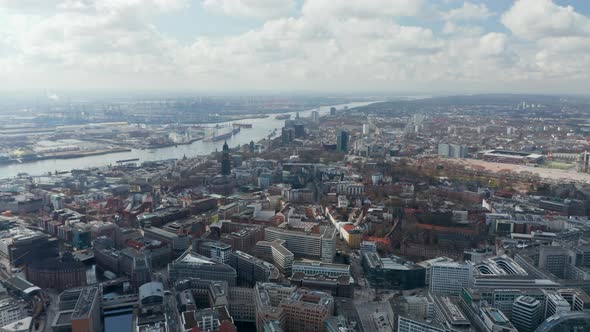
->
left=0, top=102, right=372, bottom=179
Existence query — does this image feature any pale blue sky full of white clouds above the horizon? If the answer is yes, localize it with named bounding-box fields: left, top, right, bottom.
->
left=0, top=0, right=590, bottom=94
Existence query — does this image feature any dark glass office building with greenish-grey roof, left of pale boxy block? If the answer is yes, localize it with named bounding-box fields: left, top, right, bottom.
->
left=362, top=252, right=426, bottom=290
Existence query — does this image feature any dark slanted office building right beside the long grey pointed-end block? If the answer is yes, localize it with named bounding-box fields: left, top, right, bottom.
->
left=229, top=250, right=280, bottom=287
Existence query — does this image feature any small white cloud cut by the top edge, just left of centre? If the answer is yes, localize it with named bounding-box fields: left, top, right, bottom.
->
left=203, top=0, right=295, bottom=19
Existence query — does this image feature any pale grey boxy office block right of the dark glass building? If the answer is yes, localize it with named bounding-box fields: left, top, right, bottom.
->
left=430, top=262, right=473, bottom=295
